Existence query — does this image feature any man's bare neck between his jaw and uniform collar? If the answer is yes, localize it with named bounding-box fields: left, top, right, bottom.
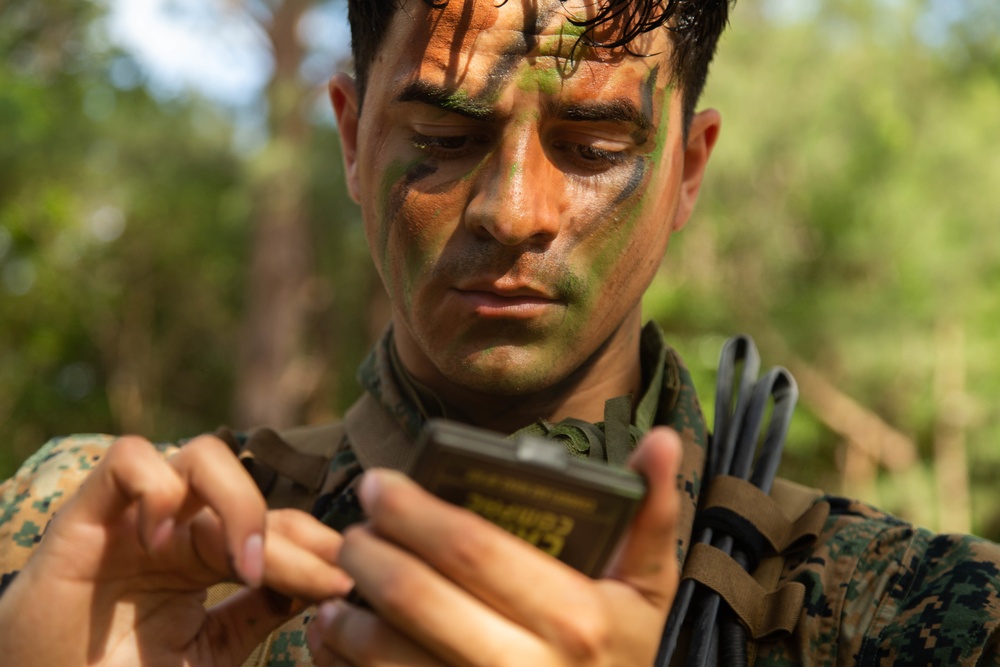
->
left=397, top=307, right=642, bottom=433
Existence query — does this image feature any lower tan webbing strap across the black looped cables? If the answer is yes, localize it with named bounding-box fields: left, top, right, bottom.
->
left=681, top=544, right=806, bottom=639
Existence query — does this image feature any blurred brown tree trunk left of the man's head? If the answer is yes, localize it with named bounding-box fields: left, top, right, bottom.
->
left=234, top=0, right=313, bottom=428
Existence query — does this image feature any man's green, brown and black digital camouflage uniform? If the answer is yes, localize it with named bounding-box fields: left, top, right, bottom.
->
left=0, top=325, right=1000, bottom=667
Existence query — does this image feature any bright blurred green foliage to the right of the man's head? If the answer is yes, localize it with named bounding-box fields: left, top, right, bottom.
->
left=646, top=2, right=1000, bottom=536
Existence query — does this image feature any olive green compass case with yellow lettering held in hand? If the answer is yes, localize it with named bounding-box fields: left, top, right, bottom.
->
left=409, top=419, right=646, bottom=577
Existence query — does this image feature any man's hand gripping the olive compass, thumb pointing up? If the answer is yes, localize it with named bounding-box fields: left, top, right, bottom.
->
left=308, top=429, right=681, bottom=667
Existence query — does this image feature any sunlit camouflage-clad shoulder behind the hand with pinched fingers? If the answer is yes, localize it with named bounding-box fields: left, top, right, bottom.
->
left=0, top=435, right=173, bottom=592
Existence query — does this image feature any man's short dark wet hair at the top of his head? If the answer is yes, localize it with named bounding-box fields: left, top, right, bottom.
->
left=347, top=0, right=735, bottom=129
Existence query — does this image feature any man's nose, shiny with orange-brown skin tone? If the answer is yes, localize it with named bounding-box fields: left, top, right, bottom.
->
left=465, top=128, right=563, bottom=246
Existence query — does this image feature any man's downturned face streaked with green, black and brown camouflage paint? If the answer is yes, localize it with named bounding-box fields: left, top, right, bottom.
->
left=350, top=0, right=688, bottom=404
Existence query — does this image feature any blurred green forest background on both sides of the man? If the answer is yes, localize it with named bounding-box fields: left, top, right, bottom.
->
left=0, top=0, right=1000, bottom=539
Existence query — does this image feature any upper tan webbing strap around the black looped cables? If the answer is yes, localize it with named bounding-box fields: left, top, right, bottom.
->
left=702, top=475, right=830, bottom=554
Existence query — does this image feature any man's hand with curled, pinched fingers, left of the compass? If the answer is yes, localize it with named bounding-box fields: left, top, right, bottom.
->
left=0, top=436, right=351, bottom=667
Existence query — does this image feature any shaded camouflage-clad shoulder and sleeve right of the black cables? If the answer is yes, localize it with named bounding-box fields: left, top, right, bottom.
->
left=756, top=497, right=1000, bottom=665
